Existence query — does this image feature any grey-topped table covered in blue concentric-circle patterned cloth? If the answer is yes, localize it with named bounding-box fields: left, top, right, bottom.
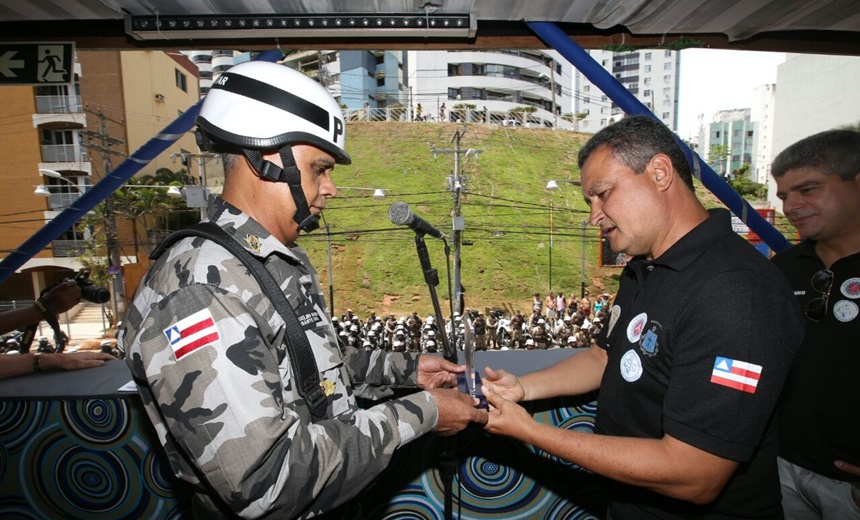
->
left=0, top=351, right=605, bottom=520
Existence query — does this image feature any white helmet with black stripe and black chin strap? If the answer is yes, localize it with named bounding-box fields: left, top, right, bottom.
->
left=197, top=61, right=352, bottom=232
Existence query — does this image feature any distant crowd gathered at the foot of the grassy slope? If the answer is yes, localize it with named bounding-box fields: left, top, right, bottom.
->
left=332, top=291, right=611, bottom=353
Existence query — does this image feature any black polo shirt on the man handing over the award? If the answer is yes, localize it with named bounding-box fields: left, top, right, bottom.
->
left=596, top=210, right=803, bottom=520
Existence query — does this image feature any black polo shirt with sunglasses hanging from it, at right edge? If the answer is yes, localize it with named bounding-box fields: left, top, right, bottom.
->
left=773, top=240, right=860, bottom=481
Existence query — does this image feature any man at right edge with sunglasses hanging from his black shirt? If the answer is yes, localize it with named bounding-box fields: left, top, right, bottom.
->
left=771, top=130, right=860, bottom=520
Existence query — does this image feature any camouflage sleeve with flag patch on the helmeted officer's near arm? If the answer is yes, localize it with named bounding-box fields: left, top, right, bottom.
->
left=131, top=284, right=438, bottom=518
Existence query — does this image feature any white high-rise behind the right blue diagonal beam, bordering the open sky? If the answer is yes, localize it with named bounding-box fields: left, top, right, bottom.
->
left=573, top=49, right=681, bottom=133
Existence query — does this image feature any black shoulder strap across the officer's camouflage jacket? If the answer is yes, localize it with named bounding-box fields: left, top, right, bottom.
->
left=149, top=222, right=328, bottom=418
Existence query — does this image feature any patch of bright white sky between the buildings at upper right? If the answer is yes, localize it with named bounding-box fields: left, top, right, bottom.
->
left=678, top=49, right=785, bottom=139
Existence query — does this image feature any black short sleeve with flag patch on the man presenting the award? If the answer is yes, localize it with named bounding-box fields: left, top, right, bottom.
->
left=663, top=272, right=803, bottom=462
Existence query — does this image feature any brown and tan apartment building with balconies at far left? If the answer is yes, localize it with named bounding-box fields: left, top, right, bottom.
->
left=0, top=51, right=199, bottom=300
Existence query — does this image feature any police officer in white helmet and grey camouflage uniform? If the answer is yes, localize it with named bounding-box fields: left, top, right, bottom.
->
left=119, top=61, right=486, bottom=520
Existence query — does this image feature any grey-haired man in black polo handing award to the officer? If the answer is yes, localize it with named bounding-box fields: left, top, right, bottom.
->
left=484, top=116, right=803, bottom=520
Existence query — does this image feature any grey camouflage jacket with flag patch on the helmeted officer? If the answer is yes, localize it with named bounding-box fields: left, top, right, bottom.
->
left=118, top=198, right=438, bottom=518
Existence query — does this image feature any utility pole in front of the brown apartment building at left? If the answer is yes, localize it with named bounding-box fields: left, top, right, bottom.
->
left=81, top=109, right=126, bottom=325
